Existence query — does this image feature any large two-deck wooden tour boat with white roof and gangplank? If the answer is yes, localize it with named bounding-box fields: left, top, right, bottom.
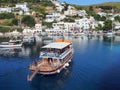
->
left=28, top=39, right=74, bottom=80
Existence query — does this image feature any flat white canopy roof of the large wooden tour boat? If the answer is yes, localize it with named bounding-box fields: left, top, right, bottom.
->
left=42, top=42, right=70, bottom=49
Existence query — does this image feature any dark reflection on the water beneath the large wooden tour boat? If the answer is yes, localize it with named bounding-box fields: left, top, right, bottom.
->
left=31, top=62, right=73, bottom=90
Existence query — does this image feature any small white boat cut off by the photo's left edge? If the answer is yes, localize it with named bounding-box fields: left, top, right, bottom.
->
left=0, top=40, right=22, bottom=48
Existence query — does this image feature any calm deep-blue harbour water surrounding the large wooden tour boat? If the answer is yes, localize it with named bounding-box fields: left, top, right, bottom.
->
left=0, top=37, right=120, bottom=90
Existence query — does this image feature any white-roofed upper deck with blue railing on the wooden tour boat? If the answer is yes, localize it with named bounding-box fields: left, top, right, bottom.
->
left=40, top=41, right=72, bottom=58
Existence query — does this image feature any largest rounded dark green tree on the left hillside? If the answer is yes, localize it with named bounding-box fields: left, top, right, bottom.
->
left=22, top=15, right=35, bottom=27
